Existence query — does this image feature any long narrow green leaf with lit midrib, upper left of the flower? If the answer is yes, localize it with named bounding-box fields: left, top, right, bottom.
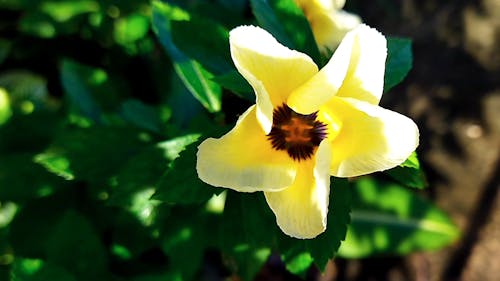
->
left=153, top=1, right=222, bottom=112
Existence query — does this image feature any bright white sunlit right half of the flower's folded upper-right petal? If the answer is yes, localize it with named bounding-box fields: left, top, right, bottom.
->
left=337, top=25, right=387, bottom=104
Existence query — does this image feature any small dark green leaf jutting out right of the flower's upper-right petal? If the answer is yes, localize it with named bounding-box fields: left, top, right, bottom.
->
left=384, top=37, right=413, bottom=92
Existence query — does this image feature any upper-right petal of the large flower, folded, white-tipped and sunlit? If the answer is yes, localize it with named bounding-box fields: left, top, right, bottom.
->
left=288, top=24, right=380, bottom=114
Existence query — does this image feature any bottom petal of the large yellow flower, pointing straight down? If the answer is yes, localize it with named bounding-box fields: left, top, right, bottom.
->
left=265, top=141, right=332, bottom=239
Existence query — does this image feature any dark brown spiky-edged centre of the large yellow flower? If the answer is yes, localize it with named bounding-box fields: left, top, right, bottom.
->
left=267, top=104, right=327, bottom=161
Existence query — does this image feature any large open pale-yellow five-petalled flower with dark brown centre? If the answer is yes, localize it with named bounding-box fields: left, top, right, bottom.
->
left=196, top=25, right=418, bottom=238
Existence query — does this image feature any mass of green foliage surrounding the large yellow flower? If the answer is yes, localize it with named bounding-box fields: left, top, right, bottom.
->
left=0, top=0, right=458, bottom=281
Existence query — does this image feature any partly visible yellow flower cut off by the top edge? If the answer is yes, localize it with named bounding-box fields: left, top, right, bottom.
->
left=295, top=0, right=361, bottom=52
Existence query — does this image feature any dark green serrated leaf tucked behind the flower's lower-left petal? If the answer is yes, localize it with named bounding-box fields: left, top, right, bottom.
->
left=153, top=143, right=222, bottom=204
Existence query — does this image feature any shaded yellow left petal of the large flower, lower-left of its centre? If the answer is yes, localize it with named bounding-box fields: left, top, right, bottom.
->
left=196, top=105, right=296, bottom=192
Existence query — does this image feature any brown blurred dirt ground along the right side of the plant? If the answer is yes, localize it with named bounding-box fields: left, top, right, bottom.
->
left=259, top=0, right=500, bottom=281
